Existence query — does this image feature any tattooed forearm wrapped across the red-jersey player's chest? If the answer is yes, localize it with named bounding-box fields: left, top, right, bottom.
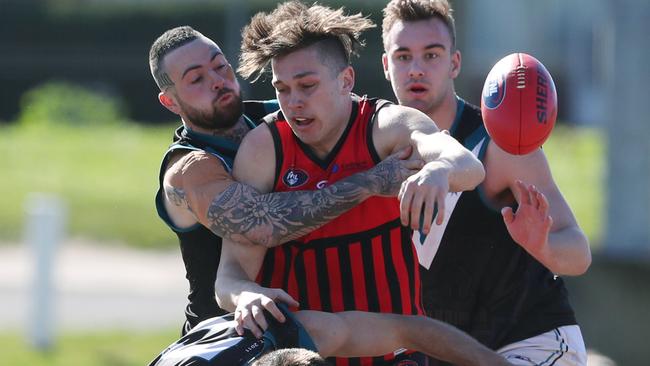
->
left=207, top=158, right=408, bottom=247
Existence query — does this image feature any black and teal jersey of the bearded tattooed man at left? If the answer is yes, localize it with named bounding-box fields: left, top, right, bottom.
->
left=156, top=100, right=279, bottom=334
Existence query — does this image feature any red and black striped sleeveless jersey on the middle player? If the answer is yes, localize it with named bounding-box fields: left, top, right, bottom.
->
left=257, top=96, right=423, bottom=365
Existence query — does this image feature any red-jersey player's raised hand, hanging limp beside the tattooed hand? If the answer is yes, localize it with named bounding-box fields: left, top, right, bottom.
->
left=398, top=161, right=449, bottom=234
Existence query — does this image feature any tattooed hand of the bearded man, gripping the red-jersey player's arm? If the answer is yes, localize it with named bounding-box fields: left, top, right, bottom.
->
left=366, top=146, right=424, bottom=197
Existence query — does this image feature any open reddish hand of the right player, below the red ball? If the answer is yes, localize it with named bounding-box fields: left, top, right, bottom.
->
left=501, top=180, right=553, bottom=257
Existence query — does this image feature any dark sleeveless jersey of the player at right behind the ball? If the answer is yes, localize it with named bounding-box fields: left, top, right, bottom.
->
left=414, top=99, right=576, bottom=349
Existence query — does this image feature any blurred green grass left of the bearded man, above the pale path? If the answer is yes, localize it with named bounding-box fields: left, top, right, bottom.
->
left=0, top=124, right=175, bottom=247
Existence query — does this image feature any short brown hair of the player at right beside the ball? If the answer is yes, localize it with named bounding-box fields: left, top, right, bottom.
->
left=381, top=0, right=456, bottom=51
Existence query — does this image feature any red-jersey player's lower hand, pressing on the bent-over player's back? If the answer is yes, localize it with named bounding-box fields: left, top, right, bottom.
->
left=235, top=288, right=299, bottom=338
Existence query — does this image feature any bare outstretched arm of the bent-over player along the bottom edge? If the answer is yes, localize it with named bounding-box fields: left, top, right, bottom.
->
left=296, top=311, right=508, bottom=365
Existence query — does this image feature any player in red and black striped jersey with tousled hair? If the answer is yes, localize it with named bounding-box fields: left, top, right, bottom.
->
left=217, top=1, right=483, bottom=365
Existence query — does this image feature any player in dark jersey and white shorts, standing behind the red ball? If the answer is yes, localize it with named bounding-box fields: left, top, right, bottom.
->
left=382, top=0, right=591, bottom=366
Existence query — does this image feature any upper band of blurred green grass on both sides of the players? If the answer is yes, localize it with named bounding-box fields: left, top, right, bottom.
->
left=0, top=124, right=605, bottom=247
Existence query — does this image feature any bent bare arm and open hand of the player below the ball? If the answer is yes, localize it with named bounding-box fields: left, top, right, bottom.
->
left=486, top=144, right=591, bottom=276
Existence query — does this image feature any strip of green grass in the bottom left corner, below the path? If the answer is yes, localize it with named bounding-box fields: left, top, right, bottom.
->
left=0, top=329, right=178, bottom=366
